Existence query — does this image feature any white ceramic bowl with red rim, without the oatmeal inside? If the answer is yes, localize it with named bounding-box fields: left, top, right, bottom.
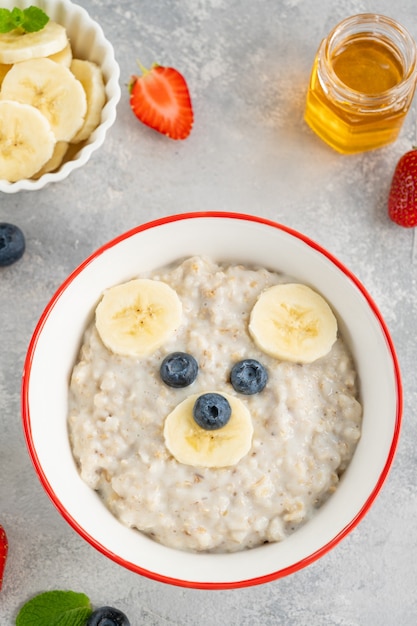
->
left=22, top=213, right=402, bottom=589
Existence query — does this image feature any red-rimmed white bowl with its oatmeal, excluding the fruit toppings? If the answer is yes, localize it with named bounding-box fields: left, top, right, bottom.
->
left=23, top=212, right=402, bottom=589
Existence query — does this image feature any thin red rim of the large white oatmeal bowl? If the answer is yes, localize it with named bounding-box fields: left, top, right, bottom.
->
left=22, top=211, right=403, bottom=589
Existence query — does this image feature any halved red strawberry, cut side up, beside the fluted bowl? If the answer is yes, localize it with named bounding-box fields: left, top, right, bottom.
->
left=129, top=65, right=194, bottom=139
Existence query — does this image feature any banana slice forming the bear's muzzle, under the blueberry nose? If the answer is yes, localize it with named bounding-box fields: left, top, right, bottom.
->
left=164, top=392, right=253, bottom=467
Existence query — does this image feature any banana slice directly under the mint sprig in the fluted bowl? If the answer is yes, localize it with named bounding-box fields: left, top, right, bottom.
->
left=0, top=20, right=68, bottom=64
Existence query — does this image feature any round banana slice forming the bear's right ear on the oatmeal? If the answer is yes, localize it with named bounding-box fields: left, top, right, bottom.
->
left=249, top=283, right=337, bottom=363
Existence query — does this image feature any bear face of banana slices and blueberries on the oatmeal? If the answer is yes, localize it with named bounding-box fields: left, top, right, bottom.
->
left=95, top=270, right=337, bottom=468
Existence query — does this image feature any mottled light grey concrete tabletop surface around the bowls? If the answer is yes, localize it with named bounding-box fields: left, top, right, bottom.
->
left=0, top=0, right=417, bottom=626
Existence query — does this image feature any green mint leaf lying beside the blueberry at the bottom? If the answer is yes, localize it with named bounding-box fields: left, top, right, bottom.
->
left=16, top=591, right=92, bottom=626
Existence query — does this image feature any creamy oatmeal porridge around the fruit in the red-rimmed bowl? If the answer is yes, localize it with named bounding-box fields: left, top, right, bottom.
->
left=68, top=257, right=362, bottom=552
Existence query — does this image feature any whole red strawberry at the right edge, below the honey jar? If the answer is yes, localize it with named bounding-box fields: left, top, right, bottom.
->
left=388, top=149, right=417, bottom=228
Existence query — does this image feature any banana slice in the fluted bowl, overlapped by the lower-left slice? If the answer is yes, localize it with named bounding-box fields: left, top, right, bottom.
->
left=0, top=59, right=87, bottom=141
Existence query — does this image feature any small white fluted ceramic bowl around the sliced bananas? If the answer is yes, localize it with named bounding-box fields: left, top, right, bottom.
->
left=0, top=0, right=121, bottom=193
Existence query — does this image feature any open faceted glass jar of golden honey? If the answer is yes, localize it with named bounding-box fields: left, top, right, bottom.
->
left=304, top=13, right=417, bottom=154
